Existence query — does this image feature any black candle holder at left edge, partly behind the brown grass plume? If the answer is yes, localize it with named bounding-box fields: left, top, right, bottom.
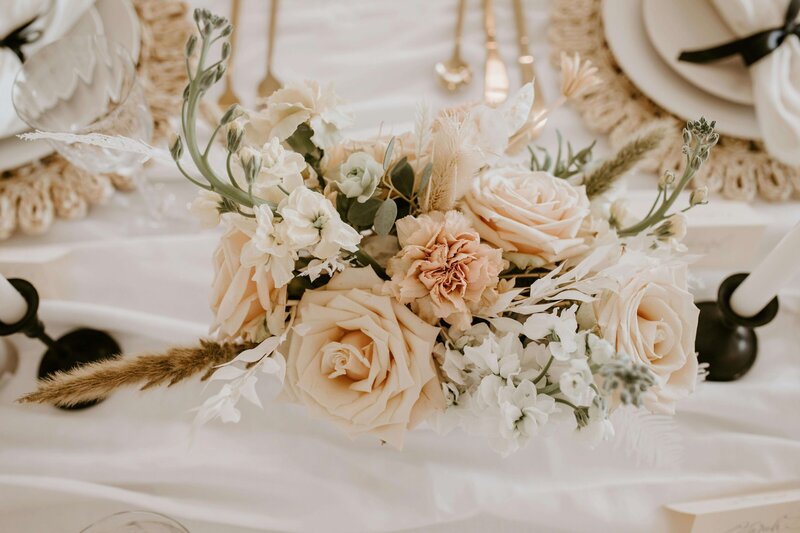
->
left=0, top=278, right=121, bottom=410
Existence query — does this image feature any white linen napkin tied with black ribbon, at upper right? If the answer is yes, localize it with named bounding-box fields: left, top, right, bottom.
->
left=711, top=0, right=800, bottom=166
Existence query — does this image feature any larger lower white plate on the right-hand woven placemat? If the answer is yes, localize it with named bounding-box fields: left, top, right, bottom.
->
left=603, top=0, right=761, bottom=140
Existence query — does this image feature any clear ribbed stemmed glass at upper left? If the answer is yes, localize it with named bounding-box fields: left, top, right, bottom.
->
left=12, top=35, right=169, bottom=219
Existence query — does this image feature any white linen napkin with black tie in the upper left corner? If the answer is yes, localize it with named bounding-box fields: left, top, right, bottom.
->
left=0, top=0, right=94, bottom=138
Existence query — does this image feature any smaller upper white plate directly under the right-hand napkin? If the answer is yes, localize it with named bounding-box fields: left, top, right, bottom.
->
left=644, top=0, right=753, bottom=105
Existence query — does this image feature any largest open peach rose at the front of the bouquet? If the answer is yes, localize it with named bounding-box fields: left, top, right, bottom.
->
left=284, top=267, right=445, bottom=449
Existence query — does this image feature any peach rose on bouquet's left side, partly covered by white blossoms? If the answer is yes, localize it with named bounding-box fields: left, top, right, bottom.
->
left=210, top=217, right=286, bottom=342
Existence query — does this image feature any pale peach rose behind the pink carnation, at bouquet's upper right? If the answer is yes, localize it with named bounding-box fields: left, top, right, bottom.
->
left=462, top=167, right=590, bottom=266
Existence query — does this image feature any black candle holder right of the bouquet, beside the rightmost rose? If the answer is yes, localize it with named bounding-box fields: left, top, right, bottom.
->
left=695, top=274, right=778, bottom=381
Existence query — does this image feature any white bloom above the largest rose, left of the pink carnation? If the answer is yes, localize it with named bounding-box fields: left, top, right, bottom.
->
left=278, top=187, right=361, bottom=259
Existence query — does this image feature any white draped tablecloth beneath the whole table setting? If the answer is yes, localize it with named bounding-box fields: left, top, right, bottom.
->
left=0, top=0, right=800, bottom=533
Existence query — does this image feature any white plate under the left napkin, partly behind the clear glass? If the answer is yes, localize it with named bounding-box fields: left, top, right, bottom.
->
left=0, top=0, right=141, bottom=172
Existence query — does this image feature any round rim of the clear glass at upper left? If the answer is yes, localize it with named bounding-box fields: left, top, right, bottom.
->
left=11, top=34, right=138, bottom=134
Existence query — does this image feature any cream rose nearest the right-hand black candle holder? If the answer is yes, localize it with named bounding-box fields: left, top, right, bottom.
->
left=594, top=265, right=699, bottom=414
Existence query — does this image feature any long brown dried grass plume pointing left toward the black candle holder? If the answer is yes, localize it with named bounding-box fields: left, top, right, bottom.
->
left=17, top=340, right=252, bottom=407
